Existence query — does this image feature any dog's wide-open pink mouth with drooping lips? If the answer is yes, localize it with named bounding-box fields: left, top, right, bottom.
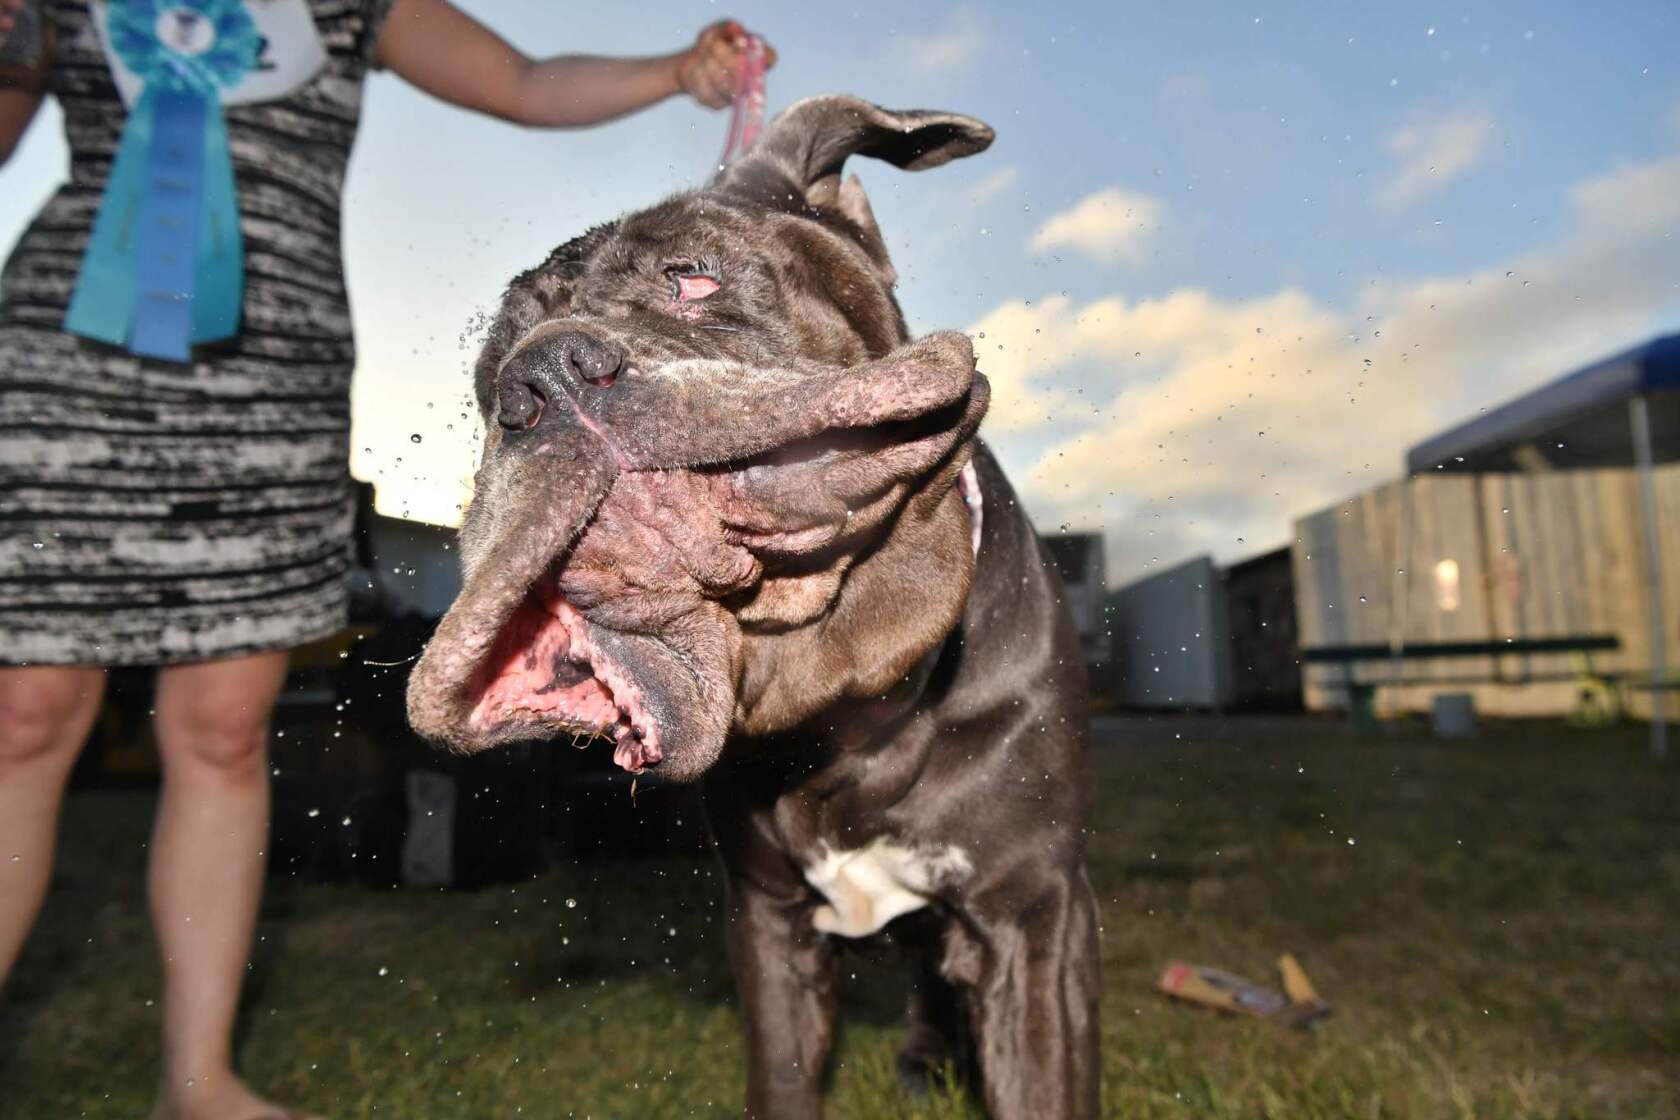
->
left=467, top=589, right=664, bottom=774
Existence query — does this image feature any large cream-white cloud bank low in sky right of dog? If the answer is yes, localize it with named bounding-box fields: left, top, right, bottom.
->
left=973, top=158, right=1680, bottom=578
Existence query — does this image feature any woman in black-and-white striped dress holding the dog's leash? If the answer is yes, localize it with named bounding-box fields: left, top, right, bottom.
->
left=0, top=0, right=772, bottom=1120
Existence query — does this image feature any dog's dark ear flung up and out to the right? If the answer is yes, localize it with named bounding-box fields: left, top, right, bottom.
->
left=714, top=96, right=993, bottom=212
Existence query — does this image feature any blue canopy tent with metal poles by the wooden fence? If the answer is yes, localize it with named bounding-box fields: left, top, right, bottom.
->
left=1393, top=334, right=1680, bottom=757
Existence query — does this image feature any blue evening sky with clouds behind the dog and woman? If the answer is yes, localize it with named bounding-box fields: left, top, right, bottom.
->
left=0, top=0, right=1680, bottom=583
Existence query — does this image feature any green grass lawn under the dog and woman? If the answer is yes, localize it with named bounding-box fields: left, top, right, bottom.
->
left=0, top=725, right=1680, bottom=1120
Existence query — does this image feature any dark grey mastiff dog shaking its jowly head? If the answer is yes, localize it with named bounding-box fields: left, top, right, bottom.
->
left=408, top=96, right=1099, bottom=1120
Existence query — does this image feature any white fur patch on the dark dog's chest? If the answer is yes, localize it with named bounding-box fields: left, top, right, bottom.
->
left=805, top=836, right=974, bottom=937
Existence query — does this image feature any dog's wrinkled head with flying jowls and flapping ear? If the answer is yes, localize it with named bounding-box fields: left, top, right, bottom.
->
left=408, top=97, right=991, bottom=777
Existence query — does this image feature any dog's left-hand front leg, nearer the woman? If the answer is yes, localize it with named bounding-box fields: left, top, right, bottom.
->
left=729, top=887, right=837, bottom=1120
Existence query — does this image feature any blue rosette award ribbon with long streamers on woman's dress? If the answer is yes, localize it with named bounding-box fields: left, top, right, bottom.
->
left=64, top=0, right=262, bottom=361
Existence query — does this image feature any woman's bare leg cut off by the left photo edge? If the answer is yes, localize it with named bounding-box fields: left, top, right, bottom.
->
left=0, top=665, right=104, bottom=986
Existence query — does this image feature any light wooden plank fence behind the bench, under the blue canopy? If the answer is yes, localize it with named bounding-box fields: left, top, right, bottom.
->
left=1292, top=467, right=1680, bottom=715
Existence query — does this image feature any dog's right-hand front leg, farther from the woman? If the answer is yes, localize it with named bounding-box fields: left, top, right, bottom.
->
left=969, top=871, right=1100, bottom=1120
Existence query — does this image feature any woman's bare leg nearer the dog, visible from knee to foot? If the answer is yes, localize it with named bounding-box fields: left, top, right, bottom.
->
left=150, top=653, right=286, bottom=1120
